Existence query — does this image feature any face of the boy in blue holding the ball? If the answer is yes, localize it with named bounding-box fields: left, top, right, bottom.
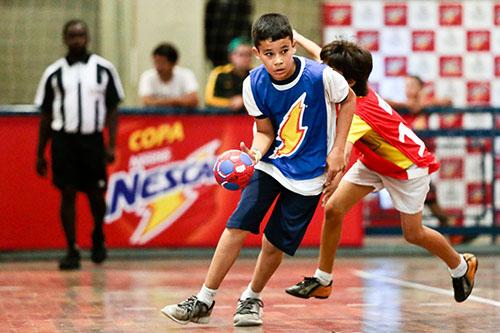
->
left=253, top=37, right=295, bottom=81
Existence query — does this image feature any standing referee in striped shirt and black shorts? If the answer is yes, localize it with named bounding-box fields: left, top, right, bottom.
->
left=35, top=20, right=124, bottom=270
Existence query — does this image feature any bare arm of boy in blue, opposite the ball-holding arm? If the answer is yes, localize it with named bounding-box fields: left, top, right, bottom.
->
left=325, top=88, right=356, bottom=186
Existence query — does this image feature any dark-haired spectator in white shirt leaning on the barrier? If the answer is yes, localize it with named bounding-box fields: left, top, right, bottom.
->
left=139, top=43, right=198, bottom=108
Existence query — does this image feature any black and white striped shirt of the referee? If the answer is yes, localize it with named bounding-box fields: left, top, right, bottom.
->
left=35, top=54, right=124, bottom=134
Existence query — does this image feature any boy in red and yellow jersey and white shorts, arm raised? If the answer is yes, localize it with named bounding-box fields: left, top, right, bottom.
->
left=286, top=34, right=478, bottom=302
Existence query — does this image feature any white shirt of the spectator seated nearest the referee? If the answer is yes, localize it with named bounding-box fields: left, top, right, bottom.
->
left=139, top=66, right=198, bottom=98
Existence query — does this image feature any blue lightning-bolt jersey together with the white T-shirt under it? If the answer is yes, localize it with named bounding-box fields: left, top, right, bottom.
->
left=243, top=57, right=348, bottom=195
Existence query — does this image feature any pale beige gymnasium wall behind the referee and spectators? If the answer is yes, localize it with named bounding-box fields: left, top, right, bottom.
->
left=0, top=0, right=321, bottom=106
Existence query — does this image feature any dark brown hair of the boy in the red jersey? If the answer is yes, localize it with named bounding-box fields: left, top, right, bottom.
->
left=320, top=40, right=373, bottom=96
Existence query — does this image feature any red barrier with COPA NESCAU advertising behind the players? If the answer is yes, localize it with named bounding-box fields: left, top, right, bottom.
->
left=0, top=114, right=363, bottom=249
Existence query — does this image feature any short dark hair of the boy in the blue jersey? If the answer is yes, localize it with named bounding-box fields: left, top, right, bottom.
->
left=252, top=13, right=293, bottom=48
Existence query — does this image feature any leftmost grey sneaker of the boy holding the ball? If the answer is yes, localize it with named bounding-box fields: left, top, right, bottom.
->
left=161, top=296, right=215, bottom=325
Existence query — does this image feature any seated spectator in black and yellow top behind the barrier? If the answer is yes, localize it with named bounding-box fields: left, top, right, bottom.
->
left=205, top=37, right=252, bottom=113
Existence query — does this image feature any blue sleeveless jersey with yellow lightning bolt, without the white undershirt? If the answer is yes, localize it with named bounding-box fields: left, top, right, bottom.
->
left=250, top=58, right=328, bottom=180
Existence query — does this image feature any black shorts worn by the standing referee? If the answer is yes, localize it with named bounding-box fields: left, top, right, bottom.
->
left=51, top=132, right=107, bottom=192
